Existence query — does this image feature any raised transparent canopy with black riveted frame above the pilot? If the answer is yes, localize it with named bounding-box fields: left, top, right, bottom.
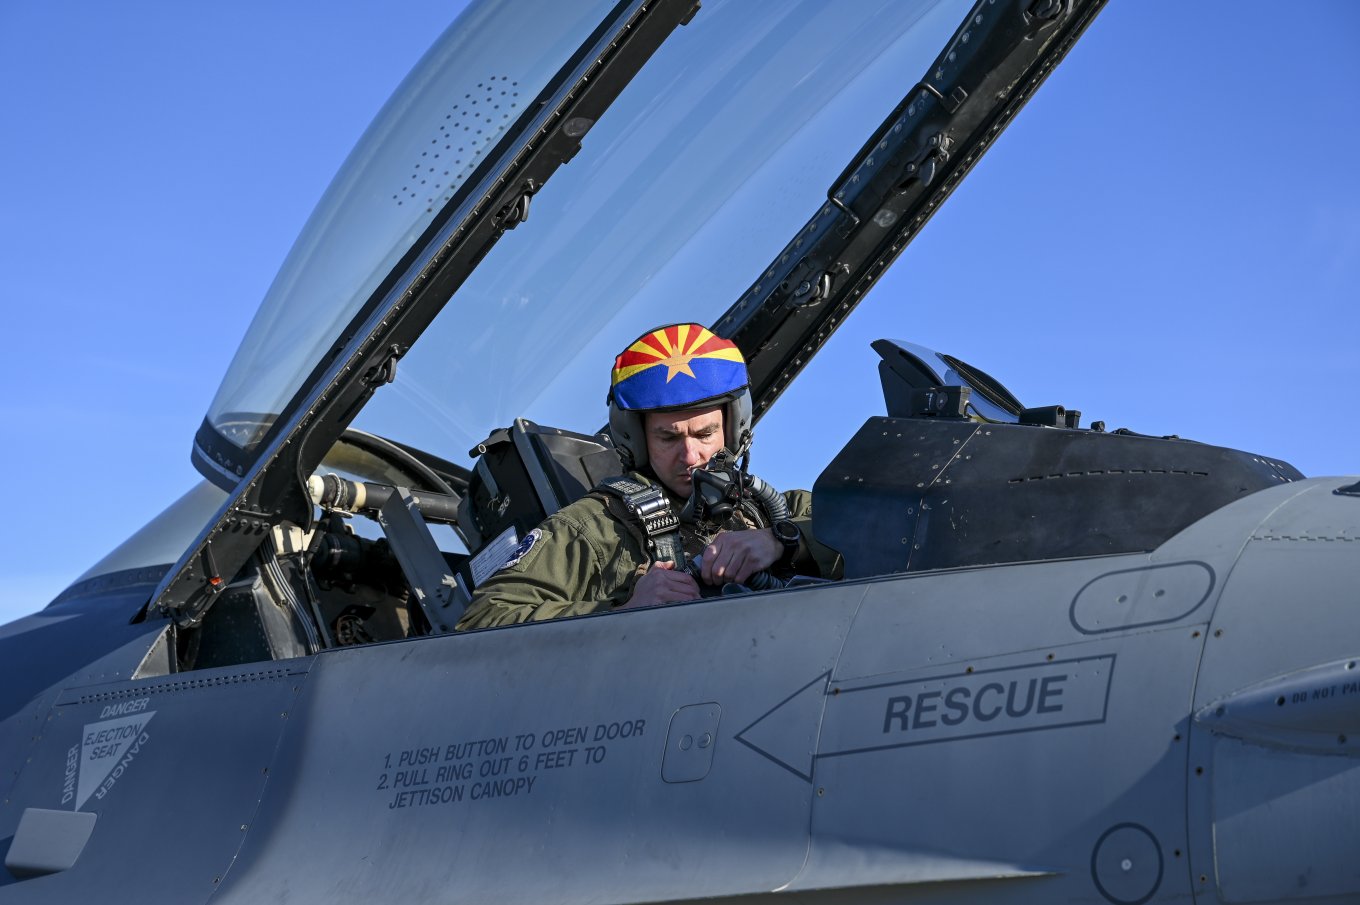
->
left=170, top=0, right=1100, bottom=617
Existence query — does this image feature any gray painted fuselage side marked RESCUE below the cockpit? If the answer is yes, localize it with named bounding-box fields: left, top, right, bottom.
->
left=0, top=480, right=1360, bottom=902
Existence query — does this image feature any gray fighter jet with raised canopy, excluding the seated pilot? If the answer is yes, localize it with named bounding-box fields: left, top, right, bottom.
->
left=0, top=0, right=1360, bottom=904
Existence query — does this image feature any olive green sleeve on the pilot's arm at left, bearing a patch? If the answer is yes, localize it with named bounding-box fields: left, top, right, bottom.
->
left=456, top=508, right=636, bottom=630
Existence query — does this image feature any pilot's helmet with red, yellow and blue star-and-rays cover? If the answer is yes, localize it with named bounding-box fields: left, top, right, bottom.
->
left=608, top=324, right=751, bottom=468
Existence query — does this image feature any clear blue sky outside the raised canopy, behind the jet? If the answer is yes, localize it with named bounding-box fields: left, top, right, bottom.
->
left=0, top=0, right=1360, bottom=622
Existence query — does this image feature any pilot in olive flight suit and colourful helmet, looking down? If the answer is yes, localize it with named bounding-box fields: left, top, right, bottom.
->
left=457, top=324, right=840, bottom=629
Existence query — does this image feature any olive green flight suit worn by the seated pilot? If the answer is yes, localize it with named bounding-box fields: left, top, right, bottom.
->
left=457, top=472, right=840, bottom=630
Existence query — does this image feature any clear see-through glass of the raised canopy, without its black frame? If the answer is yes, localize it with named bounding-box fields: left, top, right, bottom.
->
left=194, top=0, right=971, bottom=489
